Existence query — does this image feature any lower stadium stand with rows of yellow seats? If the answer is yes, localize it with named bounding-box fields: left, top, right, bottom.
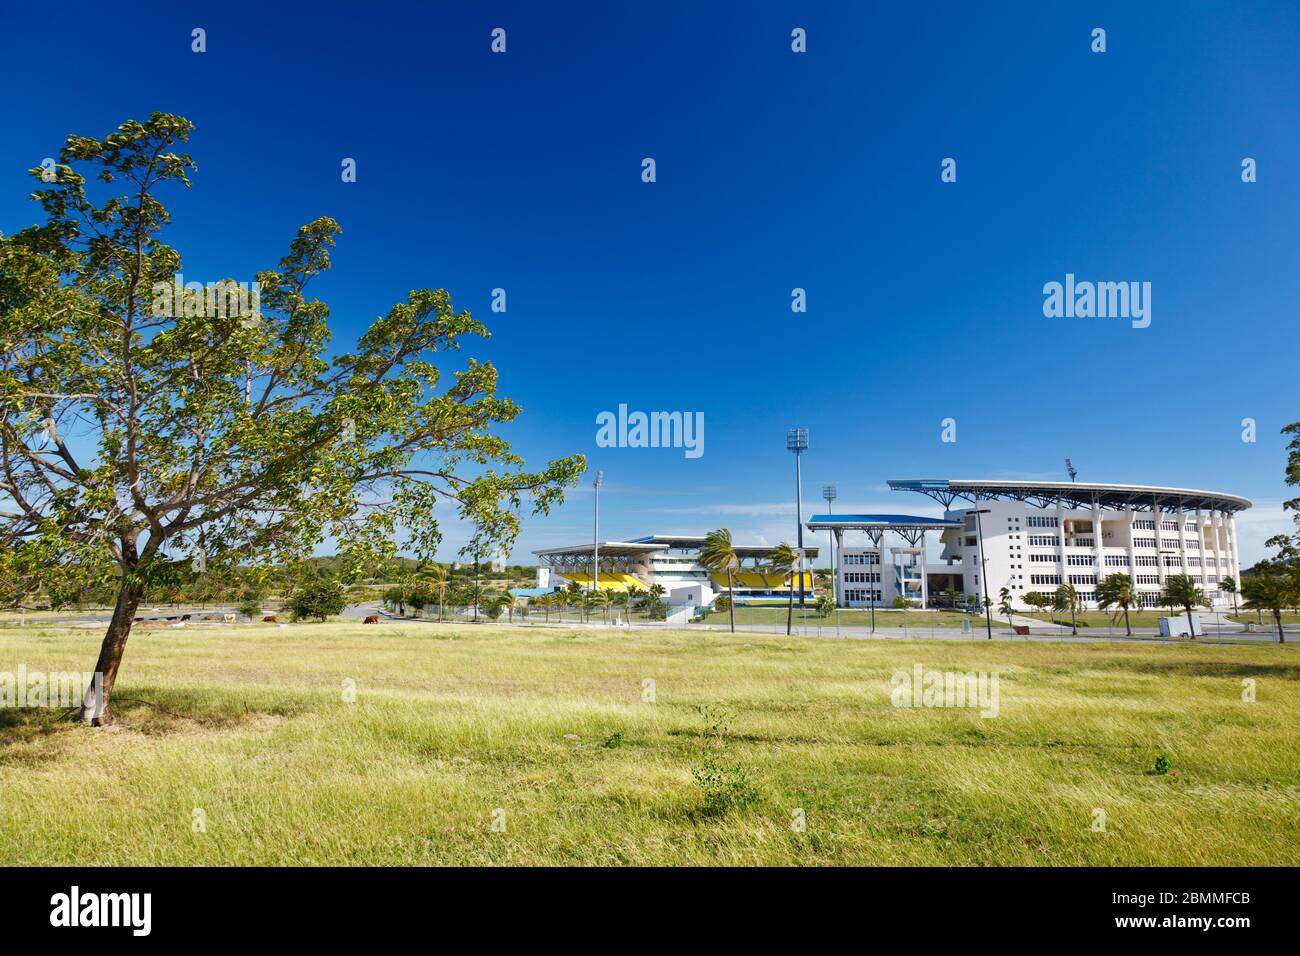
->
left=534, top=535, right=818, bottom=607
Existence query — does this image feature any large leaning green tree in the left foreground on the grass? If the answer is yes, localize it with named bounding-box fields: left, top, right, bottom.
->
left=0, top=113, right=585, bottom=724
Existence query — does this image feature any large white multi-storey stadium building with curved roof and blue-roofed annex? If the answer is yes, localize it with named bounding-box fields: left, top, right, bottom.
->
left=806, top=480, right=1251, bottom=607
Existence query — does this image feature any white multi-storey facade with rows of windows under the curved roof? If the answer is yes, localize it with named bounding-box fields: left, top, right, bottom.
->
left=930, top=501, right=1240, bottom=607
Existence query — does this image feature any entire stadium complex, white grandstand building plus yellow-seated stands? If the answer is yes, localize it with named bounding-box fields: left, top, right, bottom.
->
left=536, top=479, right=1251, bottom=609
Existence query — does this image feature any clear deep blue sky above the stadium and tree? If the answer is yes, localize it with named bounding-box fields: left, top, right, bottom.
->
left=0, top=3, right=1300, bottom=561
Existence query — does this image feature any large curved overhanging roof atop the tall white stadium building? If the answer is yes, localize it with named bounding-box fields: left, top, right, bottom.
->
left=889, top=479, right=1251, bottom=512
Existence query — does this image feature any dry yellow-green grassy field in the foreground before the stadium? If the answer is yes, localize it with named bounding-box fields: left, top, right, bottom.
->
left=0, top=623, right=1300, bottom=865
